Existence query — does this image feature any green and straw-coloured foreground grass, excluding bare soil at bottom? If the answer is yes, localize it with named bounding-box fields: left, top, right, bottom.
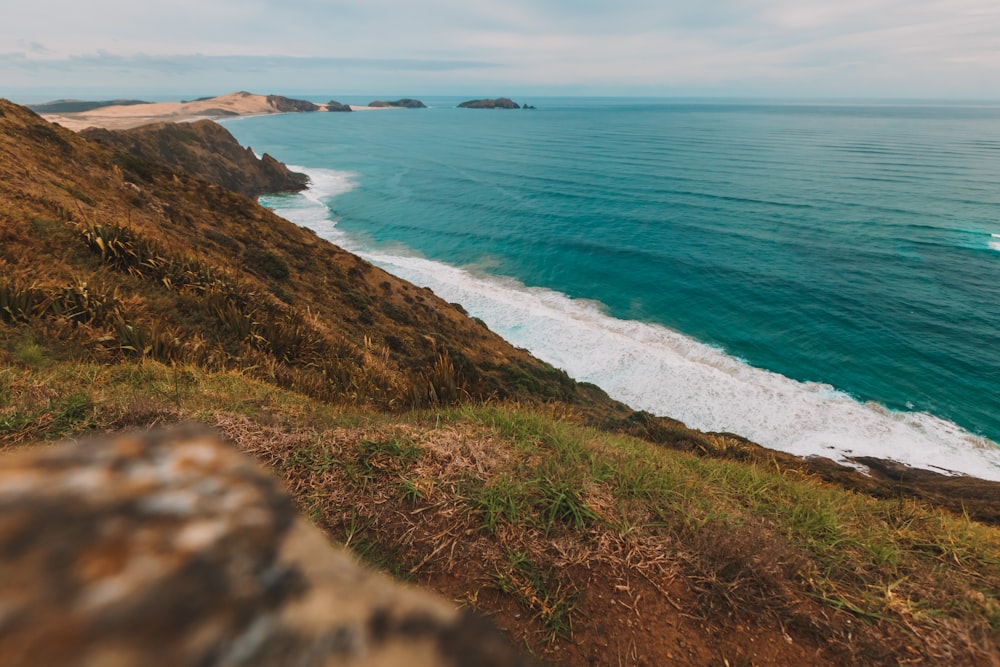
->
left=0, top=354, right=1000, bottom=664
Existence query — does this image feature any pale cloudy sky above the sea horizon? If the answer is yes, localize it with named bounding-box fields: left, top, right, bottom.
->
left=0, top=0, right=1000, bottom=103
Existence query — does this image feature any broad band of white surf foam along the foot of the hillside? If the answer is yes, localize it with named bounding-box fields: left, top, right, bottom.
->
left=264, top=167, right=1000, bottom=480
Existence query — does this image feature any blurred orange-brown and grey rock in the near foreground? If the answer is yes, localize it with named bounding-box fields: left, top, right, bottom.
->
left=0, top=427, right=528, bottom=667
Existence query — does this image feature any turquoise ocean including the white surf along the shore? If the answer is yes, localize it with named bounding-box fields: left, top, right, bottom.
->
left=225, top=98, right=1000, bottom=480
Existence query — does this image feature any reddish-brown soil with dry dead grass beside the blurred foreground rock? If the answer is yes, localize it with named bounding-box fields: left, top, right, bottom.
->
left=216, top=415, right=997, bottom=667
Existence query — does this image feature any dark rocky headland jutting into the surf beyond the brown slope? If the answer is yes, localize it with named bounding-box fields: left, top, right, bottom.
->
left=81, top=120, right=309, bottom=197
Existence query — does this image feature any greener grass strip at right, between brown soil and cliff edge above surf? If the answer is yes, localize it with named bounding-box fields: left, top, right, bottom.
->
left=446, top=407, right=1000, bottom=644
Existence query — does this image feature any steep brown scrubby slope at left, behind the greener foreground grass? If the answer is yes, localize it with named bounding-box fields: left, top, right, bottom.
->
left=0, top=96, right=617, bottom=409
